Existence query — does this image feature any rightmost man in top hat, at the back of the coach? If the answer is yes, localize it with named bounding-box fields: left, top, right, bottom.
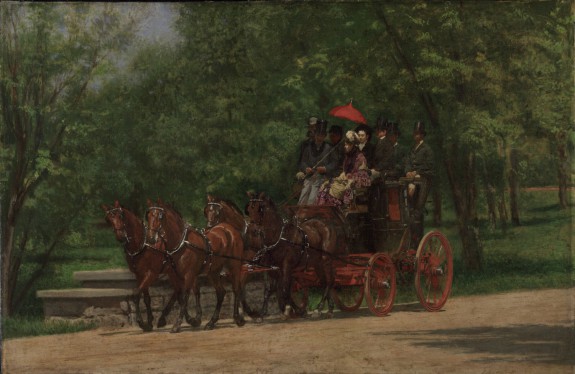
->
left=405, top=122, right=434, bottom=248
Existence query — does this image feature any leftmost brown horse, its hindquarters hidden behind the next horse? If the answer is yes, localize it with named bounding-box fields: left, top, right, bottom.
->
left=101, top=200, right=190, bottom=331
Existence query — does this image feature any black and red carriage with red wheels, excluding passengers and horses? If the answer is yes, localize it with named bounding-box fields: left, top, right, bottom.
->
left=276, top=178, right=453, bottom=316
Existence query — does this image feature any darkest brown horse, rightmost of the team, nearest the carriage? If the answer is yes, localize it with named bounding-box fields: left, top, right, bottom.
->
left=246, top=192, right=347, bottom=317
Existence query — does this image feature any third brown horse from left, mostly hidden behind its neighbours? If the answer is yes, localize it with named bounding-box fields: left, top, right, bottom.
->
left=204, top=194, right=278, bottom=322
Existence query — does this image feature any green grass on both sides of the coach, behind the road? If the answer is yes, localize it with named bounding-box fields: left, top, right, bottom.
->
left=2, top=191, right=575, bottom=338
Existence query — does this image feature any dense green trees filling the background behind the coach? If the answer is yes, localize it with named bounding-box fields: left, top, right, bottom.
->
left=0, top=1, right=573, bottom=313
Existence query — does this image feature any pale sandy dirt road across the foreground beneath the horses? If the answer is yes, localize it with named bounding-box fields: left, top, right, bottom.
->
left=2, top=288, right=575, bottom=374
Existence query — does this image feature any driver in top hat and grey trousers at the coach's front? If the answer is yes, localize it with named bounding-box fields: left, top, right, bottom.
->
left=298, top=120, right=336, bottom=205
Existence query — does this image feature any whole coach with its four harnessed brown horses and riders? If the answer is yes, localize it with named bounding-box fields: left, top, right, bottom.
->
left=102, top=121, right=453, bottom=332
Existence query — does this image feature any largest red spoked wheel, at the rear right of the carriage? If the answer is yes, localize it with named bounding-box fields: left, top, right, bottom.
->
left=415, top=231, right=453, bottom=312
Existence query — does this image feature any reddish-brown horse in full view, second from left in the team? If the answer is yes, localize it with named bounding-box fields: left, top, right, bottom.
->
left=146, top=199, right=245, bottom=332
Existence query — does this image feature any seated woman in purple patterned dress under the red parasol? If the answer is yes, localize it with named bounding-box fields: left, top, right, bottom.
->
left=316, top=131, right=371, bottom=206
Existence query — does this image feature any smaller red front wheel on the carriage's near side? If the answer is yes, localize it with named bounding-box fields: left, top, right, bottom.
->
left=365, top=253, right=397, bottom=316
